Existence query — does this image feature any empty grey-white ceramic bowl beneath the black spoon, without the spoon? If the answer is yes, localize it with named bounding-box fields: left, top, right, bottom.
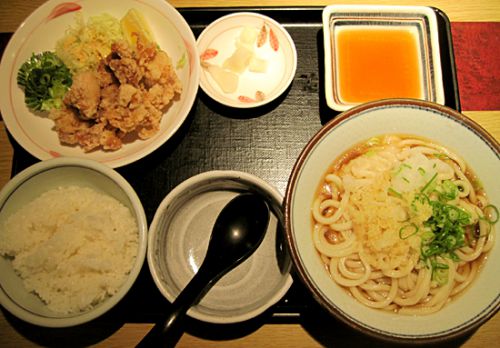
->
left=147, top=171, right=292, bottom=323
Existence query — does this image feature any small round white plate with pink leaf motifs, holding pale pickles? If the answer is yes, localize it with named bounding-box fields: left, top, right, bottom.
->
left=197, top=12, right=297, bottom=108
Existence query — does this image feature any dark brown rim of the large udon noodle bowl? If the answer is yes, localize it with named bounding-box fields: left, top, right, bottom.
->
left=284, top=98, right=500, bottom=344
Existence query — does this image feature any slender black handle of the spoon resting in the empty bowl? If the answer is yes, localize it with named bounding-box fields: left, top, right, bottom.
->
left=137, top=264, right=214, bottom=347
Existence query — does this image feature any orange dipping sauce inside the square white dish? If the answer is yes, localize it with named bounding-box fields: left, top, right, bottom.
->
left=334, top=26, right=423, bottom=103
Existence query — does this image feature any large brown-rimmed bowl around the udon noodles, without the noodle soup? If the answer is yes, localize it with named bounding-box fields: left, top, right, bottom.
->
left=285, top=99, right=500, bottom=343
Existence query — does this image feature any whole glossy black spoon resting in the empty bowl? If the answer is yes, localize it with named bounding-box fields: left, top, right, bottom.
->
left=139, top=193, right=269, bottom=347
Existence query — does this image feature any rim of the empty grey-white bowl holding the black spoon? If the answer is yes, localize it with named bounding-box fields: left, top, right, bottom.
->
left=147, top=170, right=293, bottom=324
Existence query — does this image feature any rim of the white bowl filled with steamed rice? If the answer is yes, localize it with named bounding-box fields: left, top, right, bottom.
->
left=0, top=157, right=147, bottom=328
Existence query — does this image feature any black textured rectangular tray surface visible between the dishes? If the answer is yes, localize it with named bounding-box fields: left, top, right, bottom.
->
left=1, top=7, right=460, bottom=346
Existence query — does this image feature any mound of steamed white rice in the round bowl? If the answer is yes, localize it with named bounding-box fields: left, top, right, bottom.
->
left=0, top=186, right=139, bottom=313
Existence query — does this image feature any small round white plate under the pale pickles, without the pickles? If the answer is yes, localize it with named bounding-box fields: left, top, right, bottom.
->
left=197, top=12, right=297, bottom=108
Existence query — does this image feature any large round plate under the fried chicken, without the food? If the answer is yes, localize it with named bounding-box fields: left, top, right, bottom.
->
left=0, top=0, right=200, bottom=168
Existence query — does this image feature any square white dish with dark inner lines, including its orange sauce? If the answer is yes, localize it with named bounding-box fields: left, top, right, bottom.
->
left=323, top=5, right=445, bottom=112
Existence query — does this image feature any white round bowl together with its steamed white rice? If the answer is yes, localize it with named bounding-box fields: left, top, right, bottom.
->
left=0, top=157, right=147, bottom=327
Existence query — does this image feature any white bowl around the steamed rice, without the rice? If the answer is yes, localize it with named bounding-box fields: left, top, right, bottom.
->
left=0, top=157, right=147, bottom=328
